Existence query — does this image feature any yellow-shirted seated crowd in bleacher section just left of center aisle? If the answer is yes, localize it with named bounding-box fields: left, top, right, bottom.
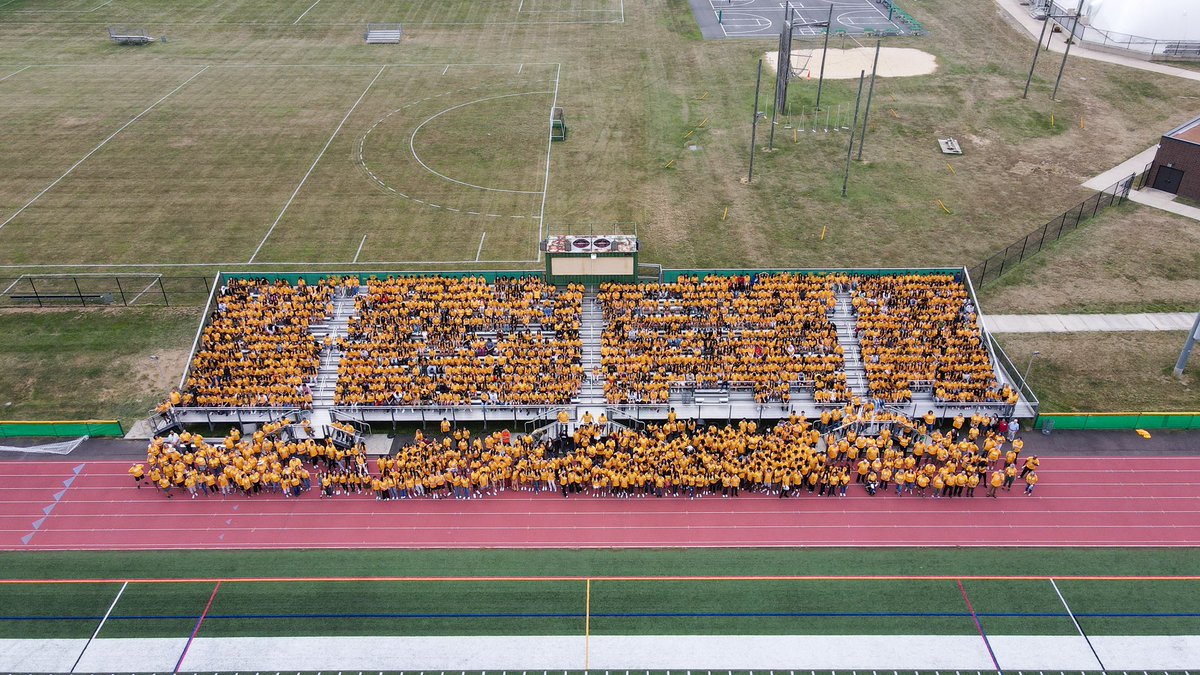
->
left=336, top=276, right=583, bottom=406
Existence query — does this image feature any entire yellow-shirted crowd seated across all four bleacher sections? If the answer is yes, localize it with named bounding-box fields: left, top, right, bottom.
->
left=162, top=273, right=1019, bottom=410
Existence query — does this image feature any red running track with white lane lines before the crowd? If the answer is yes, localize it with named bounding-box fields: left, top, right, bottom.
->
left=0, top=456, right=1200, bottom=550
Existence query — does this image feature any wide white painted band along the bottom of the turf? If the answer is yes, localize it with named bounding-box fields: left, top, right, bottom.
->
left=9, top=634, right=1200, bottom=675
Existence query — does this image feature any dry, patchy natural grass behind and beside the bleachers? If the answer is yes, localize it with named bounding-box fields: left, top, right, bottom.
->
left=0, top=0, right=1200, bottom=417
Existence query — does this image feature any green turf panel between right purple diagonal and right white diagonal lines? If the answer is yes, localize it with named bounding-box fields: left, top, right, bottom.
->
left=959, top=580, right=1076, bottom=635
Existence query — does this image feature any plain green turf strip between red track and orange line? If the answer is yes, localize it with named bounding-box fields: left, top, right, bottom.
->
left=0, top=548, right=1200, bottom=579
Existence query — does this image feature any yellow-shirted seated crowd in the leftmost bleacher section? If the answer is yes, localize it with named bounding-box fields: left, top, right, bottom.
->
left=175, top=279, right=340, bottom=407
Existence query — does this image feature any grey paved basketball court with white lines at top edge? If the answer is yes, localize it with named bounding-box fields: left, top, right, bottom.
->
left=689, top=0, right=923, bottom=40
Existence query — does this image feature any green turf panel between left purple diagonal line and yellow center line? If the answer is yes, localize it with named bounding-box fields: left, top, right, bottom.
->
left=200, top=581, right=584, bottom=638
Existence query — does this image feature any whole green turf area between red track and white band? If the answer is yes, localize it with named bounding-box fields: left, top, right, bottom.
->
left=0, top=549, right=1200, bottom=638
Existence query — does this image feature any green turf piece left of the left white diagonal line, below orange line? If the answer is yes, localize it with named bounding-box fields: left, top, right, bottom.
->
left=0, top=584, right=121, bottom=638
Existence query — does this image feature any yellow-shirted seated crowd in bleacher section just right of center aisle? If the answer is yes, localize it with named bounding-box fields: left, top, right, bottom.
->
left=598, top=273, right=848, bottom=404
